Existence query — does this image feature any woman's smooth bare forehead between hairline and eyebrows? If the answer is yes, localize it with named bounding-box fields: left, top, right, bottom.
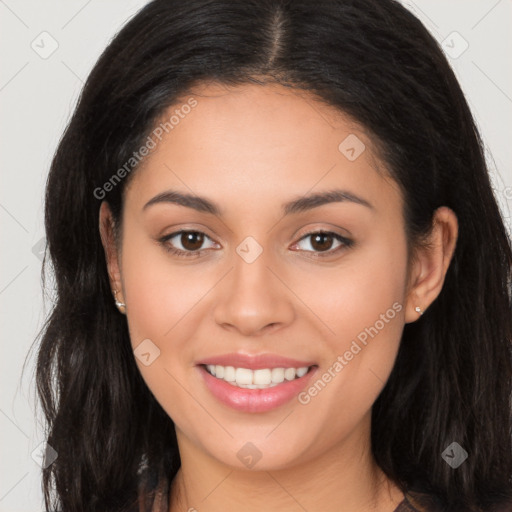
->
left=123, top=83, right=400, bottom=216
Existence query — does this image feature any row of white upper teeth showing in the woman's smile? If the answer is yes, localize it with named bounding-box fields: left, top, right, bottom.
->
left=206, top=364, right=309, bottom=389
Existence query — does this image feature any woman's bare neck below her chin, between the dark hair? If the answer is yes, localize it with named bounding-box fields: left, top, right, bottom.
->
left=170, top=416, right=403, bottom=512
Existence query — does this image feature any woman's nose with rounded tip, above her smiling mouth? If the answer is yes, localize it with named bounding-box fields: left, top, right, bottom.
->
left=214, top=251, right=295, bottom=336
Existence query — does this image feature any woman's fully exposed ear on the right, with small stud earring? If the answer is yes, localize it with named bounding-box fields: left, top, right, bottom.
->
left=405, top=206, right=458, bottom=323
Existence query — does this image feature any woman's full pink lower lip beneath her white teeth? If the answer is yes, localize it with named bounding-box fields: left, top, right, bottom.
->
left=197, top=365, right=317, bottom=412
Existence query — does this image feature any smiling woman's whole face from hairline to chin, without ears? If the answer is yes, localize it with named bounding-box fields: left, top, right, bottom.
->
left=107, top=84, right=408, bottom=469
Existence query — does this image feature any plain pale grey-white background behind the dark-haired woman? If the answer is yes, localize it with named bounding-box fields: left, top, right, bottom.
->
left=0, top=0, right=512, bottom=512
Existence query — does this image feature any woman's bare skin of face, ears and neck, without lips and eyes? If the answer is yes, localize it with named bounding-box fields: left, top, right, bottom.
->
left=100, top=84, right=457, bottom=512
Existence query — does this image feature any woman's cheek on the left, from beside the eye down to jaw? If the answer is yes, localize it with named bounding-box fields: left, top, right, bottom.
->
left=118, top=232, right=208, bottom=428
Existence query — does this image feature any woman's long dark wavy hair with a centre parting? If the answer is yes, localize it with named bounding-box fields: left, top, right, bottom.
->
left=36, top=0, right=512, bottom=512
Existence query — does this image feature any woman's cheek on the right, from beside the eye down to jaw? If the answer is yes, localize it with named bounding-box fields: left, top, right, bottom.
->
left=304, top=233, right=407, bottom=418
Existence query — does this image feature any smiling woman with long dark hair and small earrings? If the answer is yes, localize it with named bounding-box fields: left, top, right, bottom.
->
left=37, top=0, right=512, bottom=512
